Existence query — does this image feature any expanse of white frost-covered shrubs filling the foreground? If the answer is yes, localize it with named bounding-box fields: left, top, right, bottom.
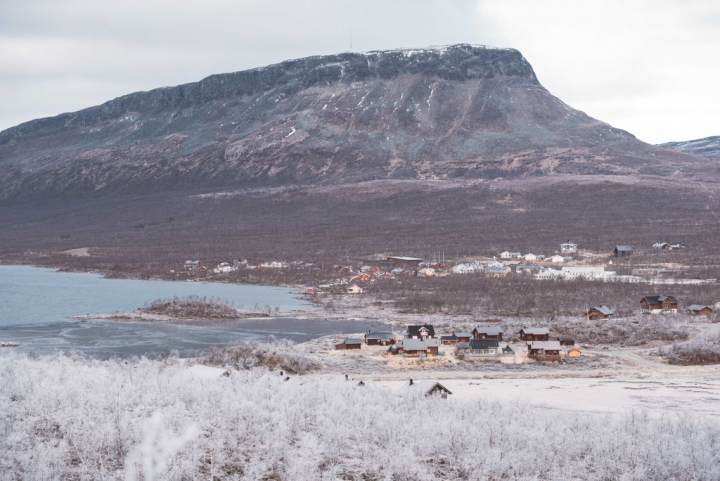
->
left=0, top=355, right=720, bottom=481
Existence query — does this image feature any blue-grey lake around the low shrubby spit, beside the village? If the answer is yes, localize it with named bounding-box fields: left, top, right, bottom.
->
left=0, top=266, right=388, bottom=358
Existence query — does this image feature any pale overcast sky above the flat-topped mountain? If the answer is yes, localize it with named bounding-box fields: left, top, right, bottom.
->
left=0, top=0, right=720, bottom=143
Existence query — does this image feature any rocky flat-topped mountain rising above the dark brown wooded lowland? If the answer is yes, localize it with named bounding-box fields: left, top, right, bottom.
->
left=0, top=45, right=707, bottom=199
